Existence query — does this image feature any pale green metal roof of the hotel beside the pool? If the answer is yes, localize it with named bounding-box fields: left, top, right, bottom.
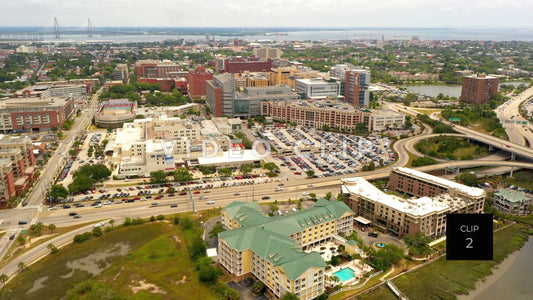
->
left=218, top=198, right=353, bottom=280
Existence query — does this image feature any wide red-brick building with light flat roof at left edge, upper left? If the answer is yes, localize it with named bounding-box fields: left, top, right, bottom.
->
left=0, top=97, right=74, bottom=133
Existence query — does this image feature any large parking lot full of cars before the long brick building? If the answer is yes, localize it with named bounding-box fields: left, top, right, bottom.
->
left=255, top=127, right=395, bottom=178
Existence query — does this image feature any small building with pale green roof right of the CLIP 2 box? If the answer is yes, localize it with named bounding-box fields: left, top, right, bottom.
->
left=492, top=189, right=532, bottom=216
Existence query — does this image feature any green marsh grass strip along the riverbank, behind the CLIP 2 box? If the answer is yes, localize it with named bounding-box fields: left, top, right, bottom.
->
left=386, top=225, right=527, bottom=300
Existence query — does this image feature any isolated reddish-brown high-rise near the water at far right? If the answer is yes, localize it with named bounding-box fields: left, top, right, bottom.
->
left=461, top=75, right=500, bottom=104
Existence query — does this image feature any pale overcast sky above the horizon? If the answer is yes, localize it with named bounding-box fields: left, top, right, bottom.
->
left=0, top=0, right=533, bottom=28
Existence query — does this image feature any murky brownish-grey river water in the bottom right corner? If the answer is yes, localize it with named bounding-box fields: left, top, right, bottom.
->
left=472, top=238, right=533, bottom=300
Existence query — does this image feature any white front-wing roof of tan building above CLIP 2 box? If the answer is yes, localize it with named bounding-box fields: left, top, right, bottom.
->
left=341, top=177, right=450, bottom=216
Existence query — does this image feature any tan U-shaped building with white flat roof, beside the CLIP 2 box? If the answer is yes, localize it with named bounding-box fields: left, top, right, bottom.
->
left=341, top=168, right=485, bottom=238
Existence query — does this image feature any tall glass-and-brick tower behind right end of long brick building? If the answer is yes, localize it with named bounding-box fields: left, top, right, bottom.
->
left=330, top=64, right=370, bottom=107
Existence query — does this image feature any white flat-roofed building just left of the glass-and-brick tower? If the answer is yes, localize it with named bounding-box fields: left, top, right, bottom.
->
left=296, top=78, right=340, bottom=99
